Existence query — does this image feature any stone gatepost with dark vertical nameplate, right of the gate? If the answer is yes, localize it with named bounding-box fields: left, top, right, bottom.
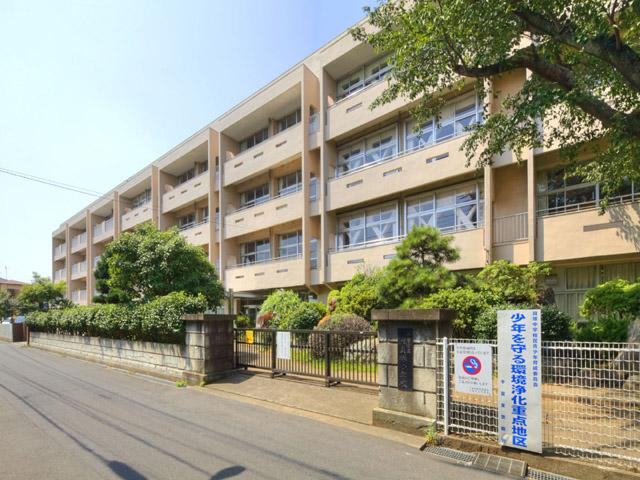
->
left=371, top=309, right=456, bottom=433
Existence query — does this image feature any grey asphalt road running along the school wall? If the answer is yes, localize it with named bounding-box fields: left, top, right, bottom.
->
left=0, top=342, right=498, bottom=480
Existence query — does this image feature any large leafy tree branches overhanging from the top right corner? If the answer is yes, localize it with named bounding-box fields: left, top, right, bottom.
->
left=353, top=0, right=640, bottom=200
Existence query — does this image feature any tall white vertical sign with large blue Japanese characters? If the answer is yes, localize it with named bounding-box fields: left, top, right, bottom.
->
left=498, top=310, right=542, bottom=453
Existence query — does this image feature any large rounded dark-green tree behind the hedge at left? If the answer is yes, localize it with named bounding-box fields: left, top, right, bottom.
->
left=96, top=222, right=224, bottom=308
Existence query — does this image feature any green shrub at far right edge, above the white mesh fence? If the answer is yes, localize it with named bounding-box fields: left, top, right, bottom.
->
left=580, top=279, right=640, bottom=323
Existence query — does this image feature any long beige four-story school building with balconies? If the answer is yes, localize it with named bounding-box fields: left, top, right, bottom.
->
left=52, top=19, right=640, bottom=314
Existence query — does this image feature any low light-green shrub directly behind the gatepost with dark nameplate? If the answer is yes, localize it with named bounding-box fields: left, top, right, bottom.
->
left=402, top=287, right=489, bottom=338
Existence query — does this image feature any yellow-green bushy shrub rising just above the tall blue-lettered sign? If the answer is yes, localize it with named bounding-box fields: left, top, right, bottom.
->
left=477, top=260, right=551, bottom=305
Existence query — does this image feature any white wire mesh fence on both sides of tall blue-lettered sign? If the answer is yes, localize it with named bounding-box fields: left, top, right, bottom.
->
left=437, top=339, right=640, bottom=469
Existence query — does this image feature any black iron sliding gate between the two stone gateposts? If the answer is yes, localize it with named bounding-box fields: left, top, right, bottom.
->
left=234, top=328, right=378, bottom=386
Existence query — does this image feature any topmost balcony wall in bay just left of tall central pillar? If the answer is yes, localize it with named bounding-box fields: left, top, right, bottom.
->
left=224, top=123, right=302, bottom=187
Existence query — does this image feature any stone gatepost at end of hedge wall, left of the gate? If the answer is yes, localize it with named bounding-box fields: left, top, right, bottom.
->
left=182, top=313, right=236, bottom=384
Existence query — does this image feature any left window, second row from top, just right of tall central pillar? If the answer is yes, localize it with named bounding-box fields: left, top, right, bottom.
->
left=336, top=127, right=397, bottom=177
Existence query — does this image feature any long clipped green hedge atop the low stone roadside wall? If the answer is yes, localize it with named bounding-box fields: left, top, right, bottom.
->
left=26, top=292, right=207, bottom=343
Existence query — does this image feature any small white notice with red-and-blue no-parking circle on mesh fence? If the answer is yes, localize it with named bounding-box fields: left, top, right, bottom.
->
left=454, top=343, right=493, bottom=396
